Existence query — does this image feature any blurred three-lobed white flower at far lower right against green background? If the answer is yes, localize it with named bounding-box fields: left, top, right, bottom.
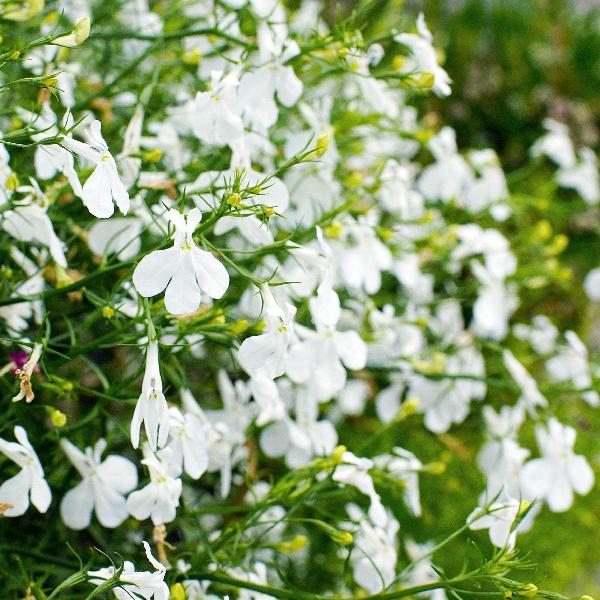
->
left=522, top=418, right=594, bottom=512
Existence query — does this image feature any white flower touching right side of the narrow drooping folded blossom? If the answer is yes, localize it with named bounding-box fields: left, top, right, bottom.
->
left=167, top=406, right=208, bottom=479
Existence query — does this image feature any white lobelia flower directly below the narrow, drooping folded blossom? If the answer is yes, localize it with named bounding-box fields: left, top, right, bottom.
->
left=126, top=444, right=181, bottom=525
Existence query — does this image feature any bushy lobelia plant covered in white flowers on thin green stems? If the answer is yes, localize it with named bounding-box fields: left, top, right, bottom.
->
left=0, top=0, right=600, bottom=600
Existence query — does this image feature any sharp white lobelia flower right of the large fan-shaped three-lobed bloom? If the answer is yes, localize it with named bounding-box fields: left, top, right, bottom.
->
left=238, top=285, right=296, bottom=379
